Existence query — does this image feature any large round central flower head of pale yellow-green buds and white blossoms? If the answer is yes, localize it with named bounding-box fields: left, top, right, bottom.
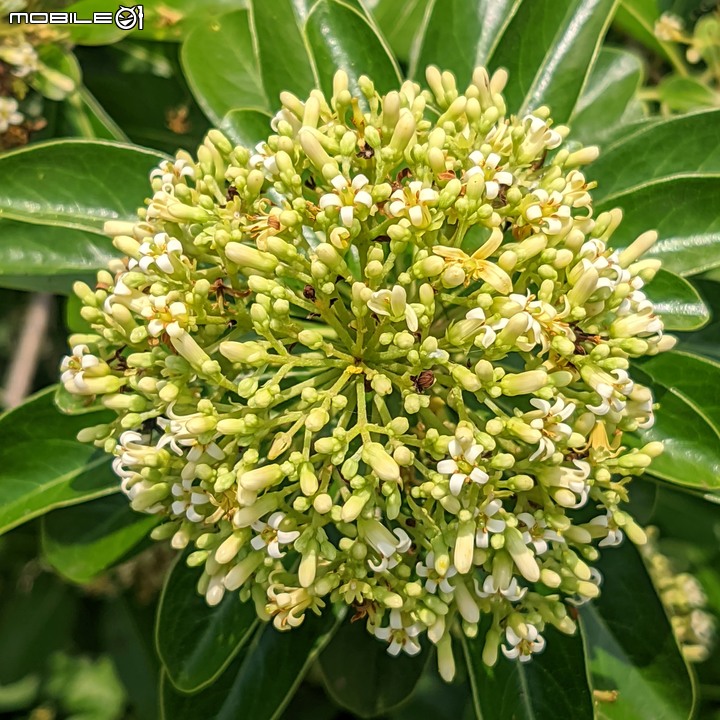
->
left=62, top=68, right=672, bottom=678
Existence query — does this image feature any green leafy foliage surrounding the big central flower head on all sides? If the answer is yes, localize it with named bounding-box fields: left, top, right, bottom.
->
left=0, top=0, right=720, bottom=720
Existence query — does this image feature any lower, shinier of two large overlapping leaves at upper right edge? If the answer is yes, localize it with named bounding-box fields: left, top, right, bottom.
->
left=596, top=177, right=720, bottom=276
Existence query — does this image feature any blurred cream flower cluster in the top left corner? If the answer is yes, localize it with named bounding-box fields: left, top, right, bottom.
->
left=0, top=0, right=75, bottom=149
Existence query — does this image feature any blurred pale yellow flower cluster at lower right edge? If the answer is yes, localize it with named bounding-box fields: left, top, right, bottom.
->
left=641, top=527, right=716, bottom=662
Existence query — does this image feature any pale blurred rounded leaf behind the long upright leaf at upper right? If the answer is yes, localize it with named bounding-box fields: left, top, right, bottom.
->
left=570, top=47, right=643, bottom=145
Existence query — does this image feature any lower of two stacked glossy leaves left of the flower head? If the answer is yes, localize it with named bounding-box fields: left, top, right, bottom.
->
left=0, top=217, right=119, bottom=291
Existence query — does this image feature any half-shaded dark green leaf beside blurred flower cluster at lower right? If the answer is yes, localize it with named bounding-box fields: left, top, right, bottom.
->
left=580, top=540, right=694, bottom=720
